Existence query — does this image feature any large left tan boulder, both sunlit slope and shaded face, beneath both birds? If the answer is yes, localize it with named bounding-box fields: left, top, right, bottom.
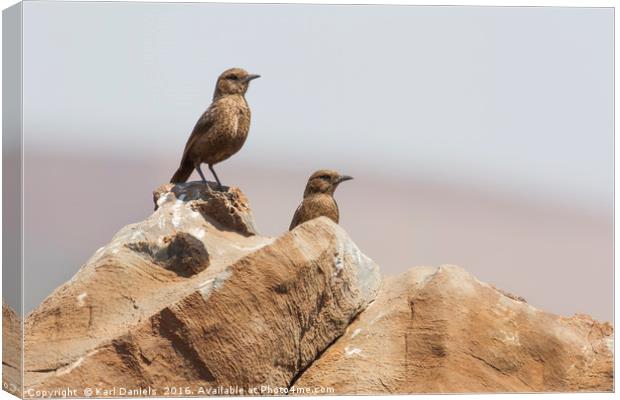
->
left=25, top=184, right=381, bottom=396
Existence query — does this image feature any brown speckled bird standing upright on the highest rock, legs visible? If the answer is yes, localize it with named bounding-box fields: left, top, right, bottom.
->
left=170, top=68, right=260, bottom=189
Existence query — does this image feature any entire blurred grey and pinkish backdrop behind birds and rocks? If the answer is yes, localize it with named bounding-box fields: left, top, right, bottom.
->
left=17, top=2, right=614, bottom=320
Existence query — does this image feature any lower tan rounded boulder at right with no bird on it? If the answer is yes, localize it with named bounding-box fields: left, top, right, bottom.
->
left=295, top=266, right=613, bottom=394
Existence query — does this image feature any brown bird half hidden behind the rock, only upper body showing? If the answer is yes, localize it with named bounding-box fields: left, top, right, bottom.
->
left=288, top=169, right=353, bottom=230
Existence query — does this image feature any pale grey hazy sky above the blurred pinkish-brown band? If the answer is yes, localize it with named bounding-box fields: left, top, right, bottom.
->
left=24, top=2, right=613, bottom=212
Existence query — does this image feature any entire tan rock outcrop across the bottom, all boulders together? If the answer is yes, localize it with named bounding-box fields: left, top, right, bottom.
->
left=12, top=182, right=613, bottom=397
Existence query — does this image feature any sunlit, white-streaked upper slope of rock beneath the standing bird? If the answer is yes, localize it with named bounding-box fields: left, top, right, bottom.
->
left=24, top=184, right=273, bottom=386
